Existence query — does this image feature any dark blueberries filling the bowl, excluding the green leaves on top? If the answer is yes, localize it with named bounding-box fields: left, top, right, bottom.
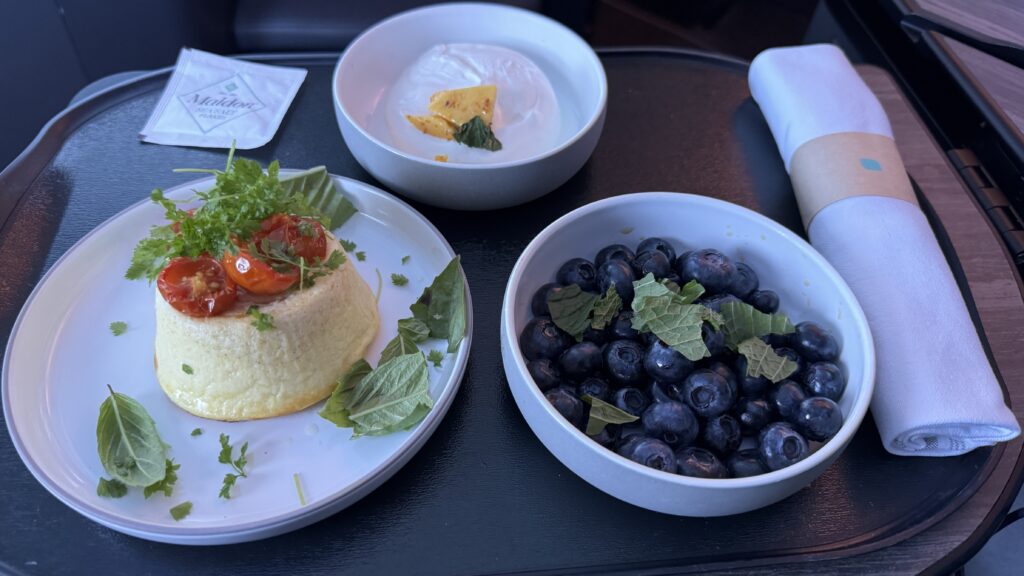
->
left=519, top=238, right=846, bottom=478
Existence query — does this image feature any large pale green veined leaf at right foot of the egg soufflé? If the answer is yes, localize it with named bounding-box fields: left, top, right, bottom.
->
left=346, top=352, right=433, bottom=438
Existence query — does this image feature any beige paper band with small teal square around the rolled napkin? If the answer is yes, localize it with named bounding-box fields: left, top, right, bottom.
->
left=790, top=132, right=918, bottom=230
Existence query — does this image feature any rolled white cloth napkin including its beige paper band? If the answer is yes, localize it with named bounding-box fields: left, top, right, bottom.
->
left=749, top=44, right=1020, bottom=456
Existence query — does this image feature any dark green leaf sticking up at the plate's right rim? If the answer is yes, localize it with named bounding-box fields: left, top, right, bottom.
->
left=409, top=256, right=466, bottom=353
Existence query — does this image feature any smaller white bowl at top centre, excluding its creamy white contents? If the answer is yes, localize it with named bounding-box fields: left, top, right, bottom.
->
left=333, top=4, right=608, bottom=210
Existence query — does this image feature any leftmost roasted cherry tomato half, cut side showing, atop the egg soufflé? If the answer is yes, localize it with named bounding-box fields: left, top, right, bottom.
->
left=157, top=256, right=238, bottom=318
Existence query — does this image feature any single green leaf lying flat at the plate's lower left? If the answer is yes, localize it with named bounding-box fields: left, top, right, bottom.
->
left=96, top=386, right=166, bottom=486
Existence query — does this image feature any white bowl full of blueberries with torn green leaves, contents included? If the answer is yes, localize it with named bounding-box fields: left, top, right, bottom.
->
left=501, top=193, right=874, bottom=517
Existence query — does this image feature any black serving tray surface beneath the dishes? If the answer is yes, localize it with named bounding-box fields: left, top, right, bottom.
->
left=0, top=50, right=1001, bottom=576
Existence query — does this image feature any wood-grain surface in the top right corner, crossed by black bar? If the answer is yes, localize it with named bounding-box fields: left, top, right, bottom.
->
left=916, top=0, right=1024, bottom=138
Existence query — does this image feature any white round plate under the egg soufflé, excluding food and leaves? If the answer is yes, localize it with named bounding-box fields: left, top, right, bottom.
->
left=2, top=172, right=473, bottom=544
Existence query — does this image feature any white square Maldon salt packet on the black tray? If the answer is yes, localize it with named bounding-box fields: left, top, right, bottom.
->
left=139, top=48, right=306, bottom=150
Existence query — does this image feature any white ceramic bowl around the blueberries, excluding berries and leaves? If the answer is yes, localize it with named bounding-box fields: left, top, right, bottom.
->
left=501, top=193, right=874, bottom=517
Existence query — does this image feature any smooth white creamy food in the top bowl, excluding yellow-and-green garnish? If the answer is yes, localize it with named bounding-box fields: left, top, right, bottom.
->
left=383, top=44, right=562, bottom=164
